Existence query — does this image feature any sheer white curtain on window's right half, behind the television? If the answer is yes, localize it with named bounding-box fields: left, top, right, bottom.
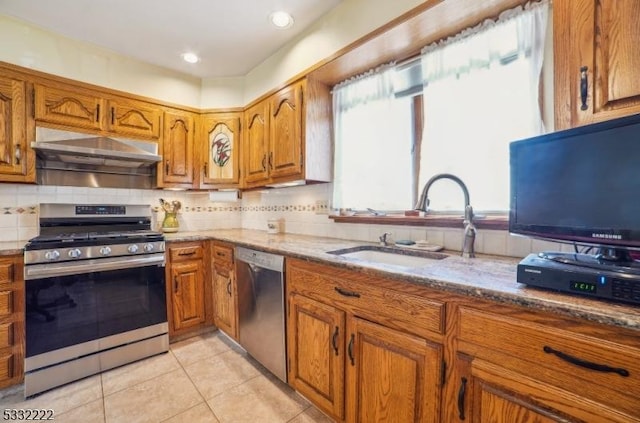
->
left=420, top=1, right=549, bottom=211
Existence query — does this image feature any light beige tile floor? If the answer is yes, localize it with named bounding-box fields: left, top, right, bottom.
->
left=0, top=332, right=338, bottom=423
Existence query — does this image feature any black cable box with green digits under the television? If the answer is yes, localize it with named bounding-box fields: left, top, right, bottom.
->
left=517, top=253, right=640, bottom=305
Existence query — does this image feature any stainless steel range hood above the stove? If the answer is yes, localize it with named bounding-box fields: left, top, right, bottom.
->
left=31, top=127, right=162, bottom=188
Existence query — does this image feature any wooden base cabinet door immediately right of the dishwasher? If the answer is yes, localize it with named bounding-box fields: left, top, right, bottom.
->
left=287, top=294, right=345, bottom=420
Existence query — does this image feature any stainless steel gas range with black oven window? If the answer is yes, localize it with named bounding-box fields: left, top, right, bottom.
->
left=24, top=204, right=169, bottom=397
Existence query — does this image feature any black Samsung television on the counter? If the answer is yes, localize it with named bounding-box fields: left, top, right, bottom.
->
left=509, top=115, right=640, bottom=249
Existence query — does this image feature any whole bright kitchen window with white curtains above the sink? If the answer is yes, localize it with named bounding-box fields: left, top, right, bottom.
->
left=333, top=3, right=547, bottom=211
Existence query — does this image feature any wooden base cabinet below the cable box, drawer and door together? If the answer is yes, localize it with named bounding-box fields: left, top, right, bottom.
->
left=444, top=303, right=640, bottom=423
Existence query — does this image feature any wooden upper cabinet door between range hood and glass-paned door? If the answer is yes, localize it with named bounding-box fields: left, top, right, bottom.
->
left=158, top=112, right=194, bottom=187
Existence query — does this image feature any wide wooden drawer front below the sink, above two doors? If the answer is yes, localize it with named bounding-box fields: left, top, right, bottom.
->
left=287, top=260, right=445, bottom=337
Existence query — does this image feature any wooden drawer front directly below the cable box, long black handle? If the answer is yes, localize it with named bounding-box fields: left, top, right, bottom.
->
left=458, top=307, right=640, bottom=415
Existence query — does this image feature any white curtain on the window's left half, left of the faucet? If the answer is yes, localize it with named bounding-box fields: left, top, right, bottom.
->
left=333, top=63, right=413, bottom=210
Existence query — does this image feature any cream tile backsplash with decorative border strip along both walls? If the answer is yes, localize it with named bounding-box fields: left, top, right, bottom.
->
left=0, top=184, right=572, bottom=257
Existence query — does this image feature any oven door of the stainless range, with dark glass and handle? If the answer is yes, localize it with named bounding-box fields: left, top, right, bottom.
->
left=25, top=254, right=167, bottom=357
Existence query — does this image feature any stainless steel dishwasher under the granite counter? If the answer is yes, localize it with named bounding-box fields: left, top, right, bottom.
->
left=235, top=247, right=287, bottom=382
